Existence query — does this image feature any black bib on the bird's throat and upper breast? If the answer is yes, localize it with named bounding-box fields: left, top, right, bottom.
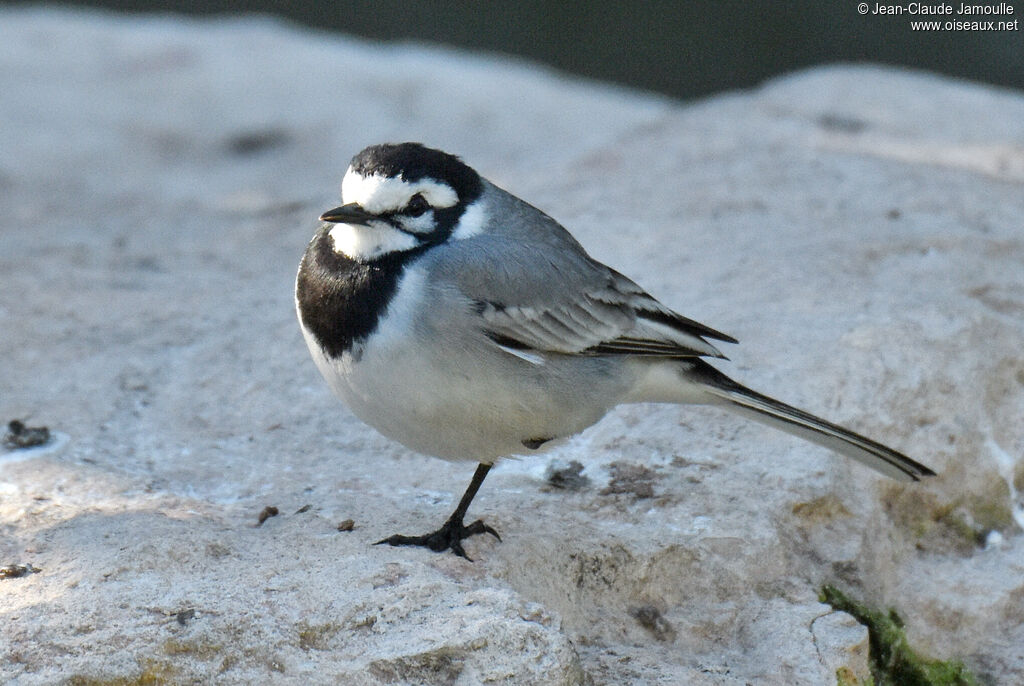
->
left=295, top=226, right=429, bottom=357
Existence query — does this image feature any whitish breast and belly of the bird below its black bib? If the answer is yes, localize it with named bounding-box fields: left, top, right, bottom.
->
left=302, top=268, right=641, bottom=464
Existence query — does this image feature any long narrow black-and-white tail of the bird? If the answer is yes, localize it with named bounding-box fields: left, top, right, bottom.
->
left=687, top=360, right=935, bottom=481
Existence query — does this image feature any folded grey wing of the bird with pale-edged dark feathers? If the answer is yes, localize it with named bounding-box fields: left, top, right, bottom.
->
left=430, top=238, right=736, bottom=359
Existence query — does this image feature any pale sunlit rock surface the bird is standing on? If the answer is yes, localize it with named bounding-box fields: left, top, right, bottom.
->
left=0, top=8, right=1024, bottom=686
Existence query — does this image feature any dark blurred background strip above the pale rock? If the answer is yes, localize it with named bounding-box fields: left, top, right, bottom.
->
left=32, top=0, right=1024, bottom=98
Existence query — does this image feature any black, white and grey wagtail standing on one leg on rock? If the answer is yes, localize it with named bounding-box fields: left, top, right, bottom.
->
left=295, top=142, right=935, bottom=559
